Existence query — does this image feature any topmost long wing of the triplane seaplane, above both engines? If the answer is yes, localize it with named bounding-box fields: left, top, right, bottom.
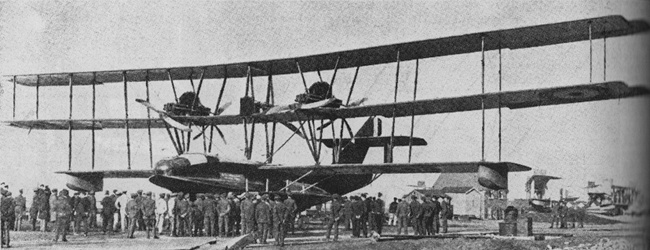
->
left=7, top=16, right=649, bottom=86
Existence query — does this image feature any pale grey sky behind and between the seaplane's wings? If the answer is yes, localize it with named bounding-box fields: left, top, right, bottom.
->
left=0, top=0, right=650, bottom=203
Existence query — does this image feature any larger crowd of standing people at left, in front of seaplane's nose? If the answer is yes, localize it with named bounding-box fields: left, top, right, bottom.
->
left=0, top=183, right=297, bottom=245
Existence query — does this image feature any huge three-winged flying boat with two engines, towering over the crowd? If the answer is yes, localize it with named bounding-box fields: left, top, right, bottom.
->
left=5, top=16, right=648, bottom=209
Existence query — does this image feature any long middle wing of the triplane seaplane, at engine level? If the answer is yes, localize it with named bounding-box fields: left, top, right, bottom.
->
left=5, top=82, right=650, bottom=129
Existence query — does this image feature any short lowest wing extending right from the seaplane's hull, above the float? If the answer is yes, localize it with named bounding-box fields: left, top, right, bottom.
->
left=259, top=162, right=530, bottom=175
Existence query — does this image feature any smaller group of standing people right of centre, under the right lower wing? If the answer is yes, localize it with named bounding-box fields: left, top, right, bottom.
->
left=325, top=193, right=452, bottom=240
